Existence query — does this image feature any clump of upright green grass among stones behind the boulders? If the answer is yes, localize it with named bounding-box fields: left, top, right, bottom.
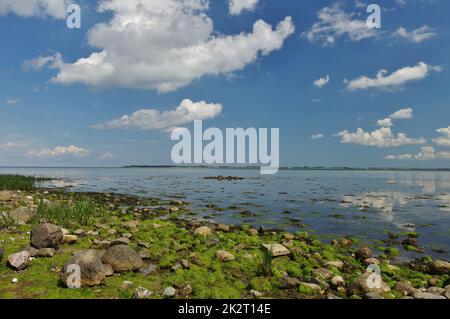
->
left=32, top=198, right=107, bottom=228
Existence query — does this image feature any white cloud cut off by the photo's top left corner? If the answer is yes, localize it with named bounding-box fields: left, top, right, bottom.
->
left=0, top=0, right=68, bottom=19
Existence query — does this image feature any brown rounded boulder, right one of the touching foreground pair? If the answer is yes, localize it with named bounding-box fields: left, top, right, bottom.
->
left=102, top=245, right=143, bottom=273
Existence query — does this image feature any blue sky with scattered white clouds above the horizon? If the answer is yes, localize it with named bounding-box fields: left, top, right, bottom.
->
left=0, top=0, right=450, bottom=167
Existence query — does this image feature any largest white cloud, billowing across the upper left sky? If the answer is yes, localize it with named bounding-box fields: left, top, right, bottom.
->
left=36, top=0, right=295, bottom=92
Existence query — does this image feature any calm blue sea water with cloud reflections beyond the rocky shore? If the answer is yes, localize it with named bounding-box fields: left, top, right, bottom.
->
left=0, top=168, right=450, bottom=259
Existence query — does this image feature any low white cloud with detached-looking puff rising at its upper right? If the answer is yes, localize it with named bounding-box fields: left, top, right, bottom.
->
left=336, top=108, right=427, bottom=148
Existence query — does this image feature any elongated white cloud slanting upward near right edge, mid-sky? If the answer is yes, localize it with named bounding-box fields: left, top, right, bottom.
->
left=347, top=62, right=442, bottom=91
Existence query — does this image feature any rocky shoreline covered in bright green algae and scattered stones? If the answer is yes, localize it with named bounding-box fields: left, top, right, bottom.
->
left=0, top=176, right=450, bottom=299
